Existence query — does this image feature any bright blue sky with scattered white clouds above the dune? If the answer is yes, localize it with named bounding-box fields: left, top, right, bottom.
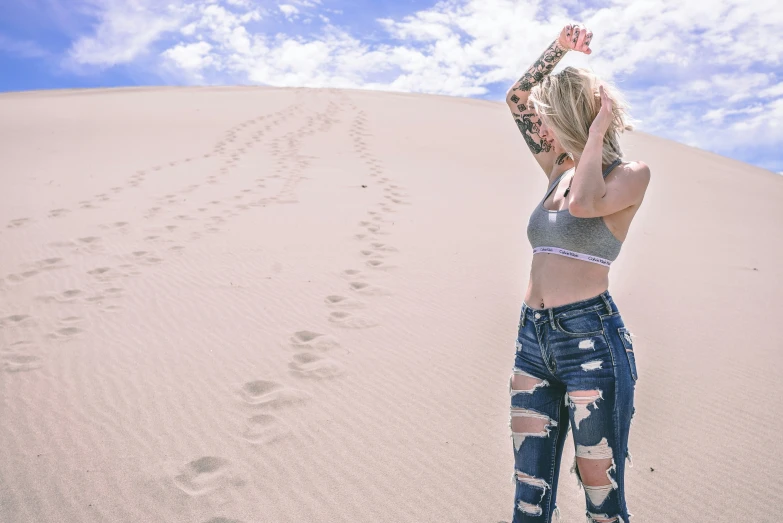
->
left=0, top=0, right=783, bottom=174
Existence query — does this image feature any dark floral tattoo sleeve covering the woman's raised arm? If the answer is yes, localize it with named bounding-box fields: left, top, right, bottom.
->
left=507, top=40, right=567, bottom=155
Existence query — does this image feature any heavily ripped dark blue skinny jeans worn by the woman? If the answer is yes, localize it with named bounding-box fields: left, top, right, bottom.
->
left=509, top=290, right=637, bottom=523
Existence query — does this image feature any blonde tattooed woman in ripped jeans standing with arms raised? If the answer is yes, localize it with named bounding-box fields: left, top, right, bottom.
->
left=506, top=24, right=650, bottom=523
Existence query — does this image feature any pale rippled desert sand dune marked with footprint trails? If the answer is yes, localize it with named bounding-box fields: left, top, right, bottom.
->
left=0, top=87, right=783, bottom=523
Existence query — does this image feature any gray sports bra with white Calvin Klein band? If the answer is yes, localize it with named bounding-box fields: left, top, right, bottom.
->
left=527, top=158, right=622, bottom=267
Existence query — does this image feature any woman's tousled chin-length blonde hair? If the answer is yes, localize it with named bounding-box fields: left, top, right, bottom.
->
left=527, top=66, right=634, bottom=164
